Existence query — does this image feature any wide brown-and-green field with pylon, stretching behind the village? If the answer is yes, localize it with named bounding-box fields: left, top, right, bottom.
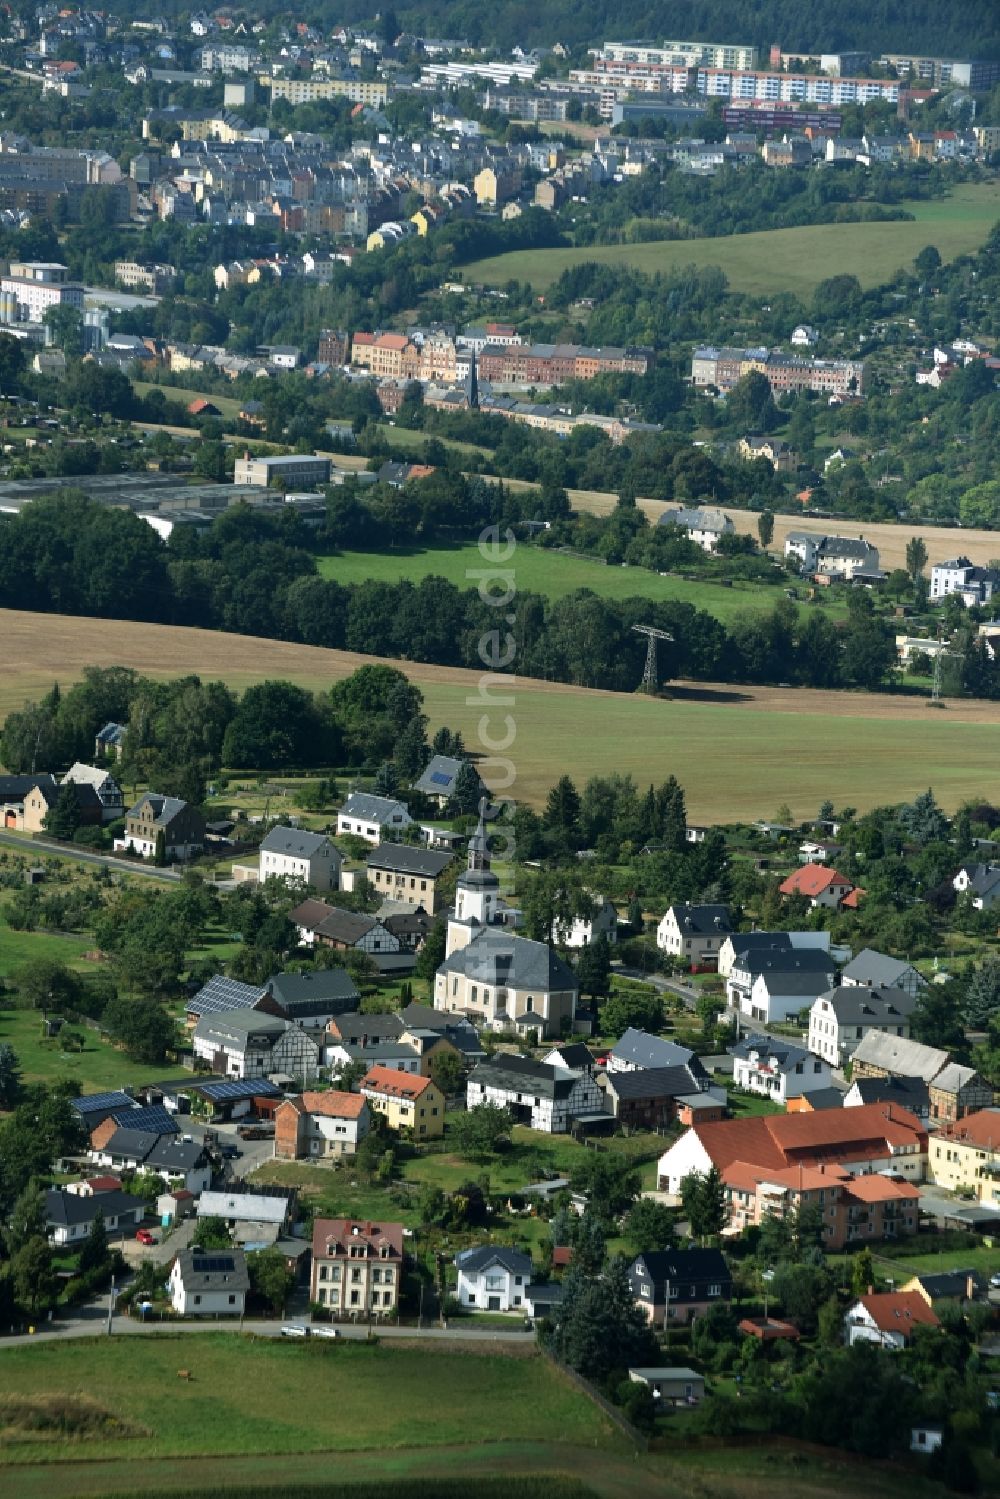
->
left=0, top=610, right=1000, bottom=821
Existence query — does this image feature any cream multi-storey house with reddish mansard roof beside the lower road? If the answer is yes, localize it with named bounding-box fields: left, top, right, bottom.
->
left=309, top=1219, right=403, bottom=1319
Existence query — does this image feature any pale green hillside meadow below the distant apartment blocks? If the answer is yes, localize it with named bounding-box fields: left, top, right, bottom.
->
left=463, top=181, right=1000, bottom=300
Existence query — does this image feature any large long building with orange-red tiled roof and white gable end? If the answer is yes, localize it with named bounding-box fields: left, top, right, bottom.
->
left=658, top=1103, right=927, bottom=1195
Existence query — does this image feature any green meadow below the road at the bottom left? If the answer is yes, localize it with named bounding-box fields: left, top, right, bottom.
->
left=0, top=1333, right=611, bottom=1463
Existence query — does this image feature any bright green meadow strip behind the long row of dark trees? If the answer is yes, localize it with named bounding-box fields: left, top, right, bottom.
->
left=318, top=544, right=844, bottom=624
